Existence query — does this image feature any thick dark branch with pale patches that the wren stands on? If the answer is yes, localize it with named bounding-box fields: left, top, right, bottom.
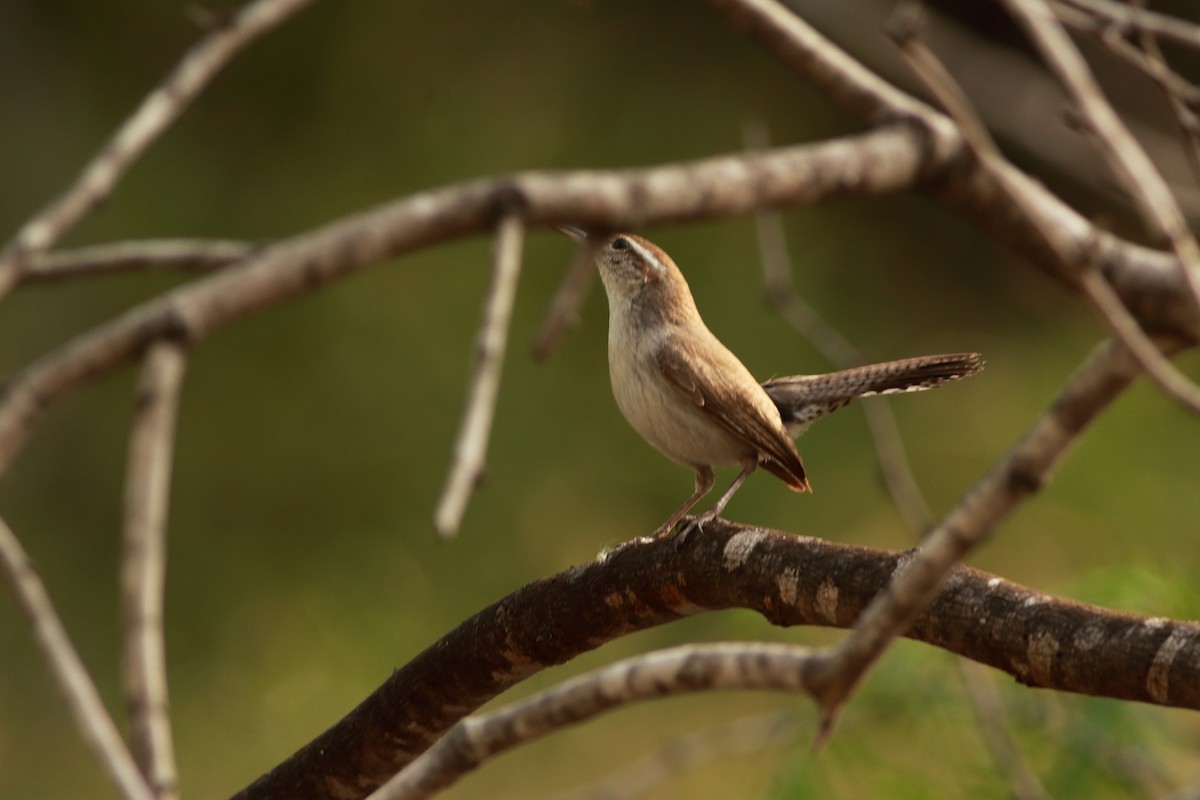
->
left=231, top=522, right=1200, bottom=800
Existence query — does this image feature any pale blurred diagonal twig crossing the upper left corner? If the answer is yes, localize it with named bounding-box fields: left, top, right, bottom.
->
left=0, top=0, right=312, bottom=297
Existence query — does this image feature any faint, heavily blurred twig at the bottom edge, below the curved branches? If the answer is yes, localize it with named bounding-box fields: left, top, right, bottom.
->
left=551, top=711, right=799, bottom=800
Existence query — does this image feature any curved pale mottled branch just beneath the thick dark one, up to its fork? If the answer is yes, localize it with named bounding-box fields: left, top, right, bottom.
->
left=371, top=642, right=812, bottom=800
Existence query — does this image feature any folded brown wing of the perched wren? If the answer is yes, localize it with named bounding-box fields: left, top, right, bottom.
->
left=656, top=339, right=809, bottom=492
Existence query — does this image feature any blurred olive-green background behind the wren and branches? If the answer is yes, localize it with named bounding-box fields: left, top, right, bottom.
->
left=0, top=0, right=1200, bottom=800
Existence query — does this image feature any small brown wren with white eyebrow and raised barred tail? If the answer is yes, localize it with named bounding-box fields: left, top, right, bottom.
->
left=559, top=227, right=983, bottom=536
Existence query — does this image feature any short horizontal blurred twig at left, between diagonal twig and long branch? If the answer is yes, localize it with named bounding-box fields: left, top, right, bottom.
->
left=20, top=239, right=260, bottom=283
